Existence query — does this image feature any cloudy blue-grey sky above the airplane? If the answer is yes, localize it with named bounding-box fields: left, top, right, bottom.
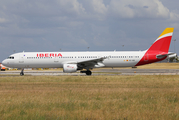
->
left=0, top=0, right=179, bottom=62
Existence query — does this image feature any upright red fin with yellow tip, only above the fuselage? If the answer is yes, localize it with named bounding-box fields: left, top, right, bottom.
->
left=147, top=28, right=174, bottom=53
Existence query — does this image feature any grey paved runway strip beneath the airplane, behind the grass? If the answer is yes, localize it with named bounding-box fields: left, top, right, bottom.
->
left=0, top=68, right=179, bottom=76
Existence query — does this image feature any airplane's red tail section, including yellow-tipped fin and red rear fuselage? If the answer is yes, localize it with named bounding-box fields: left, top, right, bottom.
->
left=136, top=28, right=174, bottom=66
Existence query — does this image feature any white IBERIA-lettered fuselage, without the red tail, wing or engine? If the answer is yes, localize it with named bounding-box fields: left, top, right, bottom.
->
left=2, top=51, right=146, bottom=68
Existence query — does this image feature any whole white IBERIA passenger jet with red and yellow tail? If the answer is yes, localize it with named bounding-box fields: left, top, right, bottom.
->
left=2, top=28, right=174, bottom=75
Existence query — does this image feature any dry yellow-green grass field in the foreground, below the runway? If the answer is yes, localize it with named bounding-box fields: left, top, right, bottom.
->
left=0, top=75, right=179, bottom=120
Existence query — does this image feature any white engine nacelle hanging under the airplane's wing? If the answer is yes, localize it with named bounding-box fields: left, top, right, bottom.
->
left=63, top=64, right=78, bottom=73
